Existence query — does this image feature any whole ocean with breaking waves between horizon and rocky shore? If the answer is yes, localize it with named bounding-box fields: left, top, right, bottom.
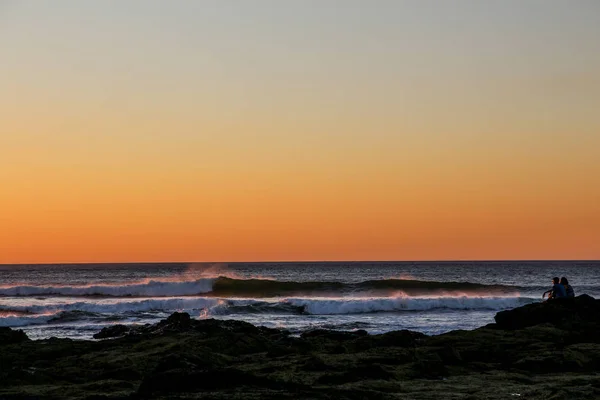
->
left=0, top=261, right=600, bottom=339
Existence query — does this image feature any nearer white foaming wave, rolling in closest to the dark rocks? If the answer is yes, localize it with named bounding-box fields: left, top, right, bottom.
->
left=0, top=296, right=536, bottom=326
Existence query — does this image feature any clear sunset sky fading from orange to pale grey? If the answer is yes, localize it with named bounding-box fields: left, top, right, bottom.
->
left=0, top=0, right=600, bottom=263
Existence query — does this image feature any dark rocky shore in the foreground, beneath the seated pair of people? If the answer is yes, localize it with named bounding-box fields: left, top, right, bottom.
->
left=0, top=295, right=600, bottom=400
